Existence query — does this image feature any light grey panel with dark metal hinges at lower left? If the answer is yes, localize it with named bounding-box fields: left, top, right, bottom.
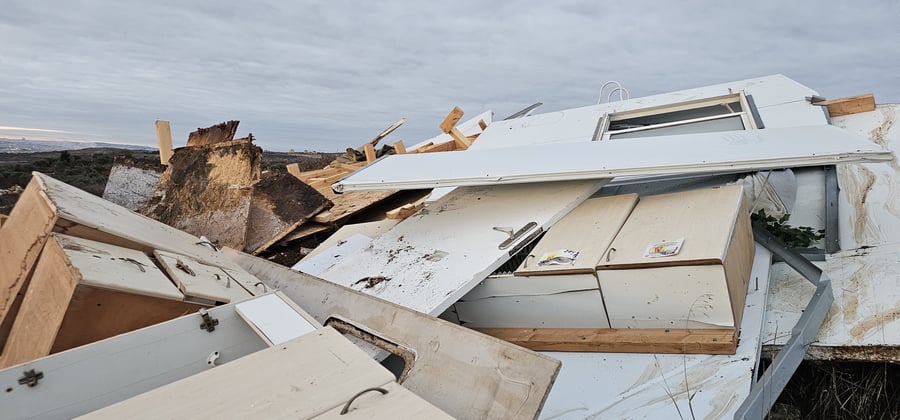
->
left=0, top=305, right=266, bottom=419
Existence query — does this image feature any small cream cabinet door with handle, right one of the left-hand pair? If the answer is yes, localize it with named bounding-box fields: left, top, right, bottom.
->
left=153, top=250, right=253, bottom=303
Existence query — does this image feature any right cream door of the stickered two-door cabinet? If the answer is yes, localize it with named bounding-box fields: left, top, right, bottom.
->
left=597, top=185, right=743, bottom=270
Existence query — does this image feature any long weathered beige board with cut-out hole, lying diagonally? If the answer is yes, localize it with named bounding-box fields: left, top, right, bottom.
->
left=225, top=250, right=559, bottom=419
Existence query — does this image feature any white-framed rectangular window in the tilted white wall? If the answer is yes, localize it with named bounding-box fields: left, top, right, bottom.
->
left=597, top=93, right=757, bottom=140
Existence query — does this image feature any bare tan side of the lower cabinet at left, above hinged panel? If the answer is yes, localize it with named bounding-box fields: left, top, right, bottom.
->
left=0, top=236, right=81, bottom=369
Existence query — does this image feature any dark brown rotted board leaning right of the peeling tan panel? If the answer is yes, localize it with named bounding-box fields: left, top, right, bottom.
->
left=244, top=173, right=333, bottom=254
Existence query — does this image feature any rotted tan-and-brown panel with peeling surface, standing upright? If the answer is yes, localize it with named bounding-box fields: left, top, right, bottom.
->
left=141, top=141, right=262, bottom=249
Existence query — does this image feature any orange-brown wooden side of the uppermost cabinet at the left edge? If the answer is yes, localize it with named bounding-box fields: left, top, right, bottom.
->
left=0, top=177, right=57, bottom=348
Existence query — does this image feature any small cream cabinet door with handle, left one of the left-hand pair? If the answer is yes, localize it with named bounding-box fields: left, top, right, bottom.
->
left=53, top=234, right=184, bottom=301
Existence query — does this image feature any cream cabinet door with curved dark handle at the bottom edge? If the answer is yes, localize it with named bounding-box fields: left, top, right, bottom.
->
left=315, top=382, right=453, bottom=420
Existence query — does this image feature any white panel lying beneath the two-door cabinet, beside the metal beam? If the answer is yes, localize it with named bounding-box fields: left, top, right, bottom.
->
left=541, top=246, right=771, bottom=419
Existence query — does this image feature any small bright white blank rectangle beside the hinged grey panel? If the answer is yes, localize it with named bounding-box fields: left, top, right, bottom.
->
left=235, top=293, right=318, bottom=345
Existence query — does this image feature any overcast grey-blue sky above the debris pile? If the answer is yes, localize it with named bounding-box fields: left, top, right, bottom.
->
left=0, top=0, right=900, bottom=151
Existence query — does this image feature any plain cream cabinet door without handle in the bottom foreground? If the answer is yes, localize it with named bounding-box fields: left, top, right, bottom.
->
left=82, top=328, right=394, bottom=419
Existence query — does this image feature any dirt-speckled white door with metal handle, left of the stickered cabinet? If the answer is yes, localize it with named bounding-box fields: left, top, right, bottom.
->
left=321, top=180, right=603, bottom=315
